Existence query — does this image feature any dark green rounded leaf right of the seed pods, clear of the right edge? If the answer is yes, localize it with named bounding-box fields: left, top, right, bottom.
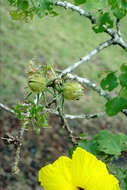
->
left=100, top=72, right=118, bottom=91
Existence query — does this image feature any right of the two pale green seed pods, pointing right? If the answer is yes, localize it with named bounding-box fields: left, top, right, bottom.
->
left=63, top=82, right=83, bottom=100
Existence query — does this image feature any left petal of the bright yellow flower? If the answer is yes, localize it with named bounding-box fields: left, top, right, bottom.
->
left=39, top=156, right=75, bottom=190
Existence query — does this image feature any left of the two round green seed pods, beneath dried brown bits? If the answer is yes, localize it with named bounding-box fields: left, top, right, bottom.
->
left=28, top=72, right=46, bottom=93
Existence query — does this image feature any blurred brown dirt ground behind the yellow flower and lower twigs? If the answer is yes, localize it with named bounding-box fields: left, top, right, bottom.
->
left=0, top=110, right=127, bottom=190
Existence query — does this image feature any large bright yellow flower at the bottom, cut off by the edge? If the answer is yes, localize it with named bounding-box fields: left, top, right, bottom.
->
left=39, top=147, right=120, bottom=190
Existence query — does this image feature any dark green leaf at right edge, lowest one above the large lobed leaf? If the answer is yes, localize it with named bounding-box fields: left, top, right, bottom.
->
left=106, top=97, right=127, bottom=116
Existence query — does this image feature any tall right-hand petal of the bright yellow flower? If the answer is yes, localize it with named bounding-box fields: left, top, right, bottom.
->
left=71, top=147, right=120, bottom=190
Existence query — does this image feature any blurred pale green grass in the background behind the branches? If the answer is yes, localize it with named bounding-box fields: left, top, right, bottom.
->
left=0, top=0, right=127, bottom=116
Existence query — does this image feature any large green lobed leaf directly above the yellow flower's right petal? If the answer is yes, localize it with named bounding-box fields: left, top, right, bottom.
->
left=78, top=130, right=127, bottom=158
